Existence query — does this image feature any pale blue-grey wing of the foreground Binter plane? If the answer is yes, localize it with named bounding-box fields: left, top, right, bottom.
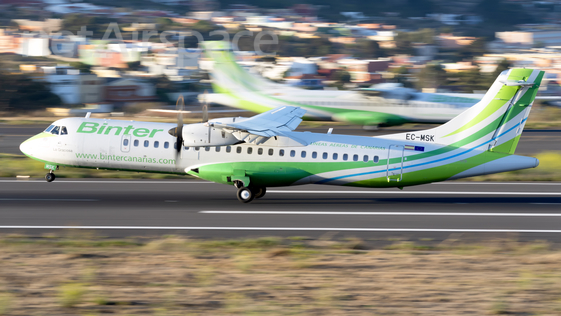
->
left=208, top=106, right=306, bottom=145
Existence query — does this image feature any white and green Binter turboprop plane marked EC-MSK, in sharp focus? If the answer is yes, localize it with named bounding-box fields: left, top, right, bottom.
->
left=20, top=69, right=544, bottom=202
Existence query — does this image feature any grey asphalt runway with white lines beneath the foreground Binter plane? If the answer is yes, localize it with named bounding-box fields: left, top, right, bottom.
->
left=0, top=179, right=561, bottom=242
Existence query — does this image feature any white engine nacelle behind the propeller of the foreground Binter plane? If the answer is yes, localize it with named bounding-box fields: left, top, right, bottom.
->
left=183, top=123, right=239, bottom=146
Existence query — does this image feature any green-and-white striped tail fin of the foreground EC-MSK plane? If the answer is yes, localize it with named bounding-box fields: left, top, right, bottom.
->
left=418, top=68, right=544, bottom=154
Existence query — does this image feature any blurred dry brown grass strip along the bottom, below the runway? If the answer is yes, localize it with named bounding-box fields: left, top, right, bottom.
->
left=0, top=236, right=561, bottom=315
